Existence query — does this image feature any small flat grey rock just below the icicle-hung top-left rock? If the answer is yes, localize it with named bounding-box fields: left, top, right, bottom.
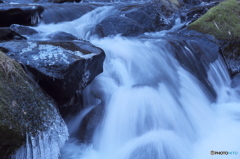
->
left=10, top=24, right=38, bottom=35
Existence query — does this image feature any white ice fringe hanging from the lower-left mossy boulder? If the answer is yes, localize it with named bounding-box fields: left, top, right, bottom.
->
left=11, top=105, right=68, bottom=159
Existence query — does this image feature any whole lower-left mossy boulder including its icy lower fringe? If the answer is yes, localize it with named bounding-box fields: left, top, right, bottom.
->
left=0, top=52, right=68, bottom=159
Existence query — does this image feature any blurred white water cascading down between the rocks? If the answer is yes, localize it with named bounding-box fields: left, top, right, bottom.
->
left=33, top=6, right=240, bottom=159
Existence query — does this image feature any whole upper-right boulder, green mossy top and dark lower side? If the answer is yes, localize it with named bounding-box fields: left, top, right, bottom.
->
left=188, top=0, right=240, bottom=75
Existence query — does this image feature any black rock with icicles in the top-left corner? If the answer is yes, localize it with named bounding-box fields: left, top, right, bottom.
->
left=0, top=4, right=44, bottom=27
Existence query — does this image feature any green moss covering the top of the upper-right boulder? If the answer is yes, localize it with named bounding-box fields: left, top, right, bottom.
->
left=188, top=0, right=240, bottom=40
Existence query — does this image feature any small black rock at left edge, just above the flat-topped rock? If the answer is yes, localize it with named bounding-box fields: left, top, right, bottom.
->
left=0, top=28, right=26, bottom=41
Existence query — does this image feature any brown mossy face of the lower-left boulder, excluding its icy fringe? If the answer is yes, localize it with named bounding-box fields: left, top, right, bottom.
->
left=0, top=51, right=66, bottom=158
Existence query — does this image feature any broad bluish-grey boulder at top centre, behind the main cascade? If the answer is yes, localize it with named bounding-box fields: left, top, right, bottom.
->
left=93, top=3, right=175, bottom=37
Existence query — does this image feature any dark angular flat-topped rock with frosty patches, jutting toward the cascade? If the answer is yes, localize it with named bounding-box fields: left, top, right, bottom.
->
left=0, top=41, right=105, bottom=116
